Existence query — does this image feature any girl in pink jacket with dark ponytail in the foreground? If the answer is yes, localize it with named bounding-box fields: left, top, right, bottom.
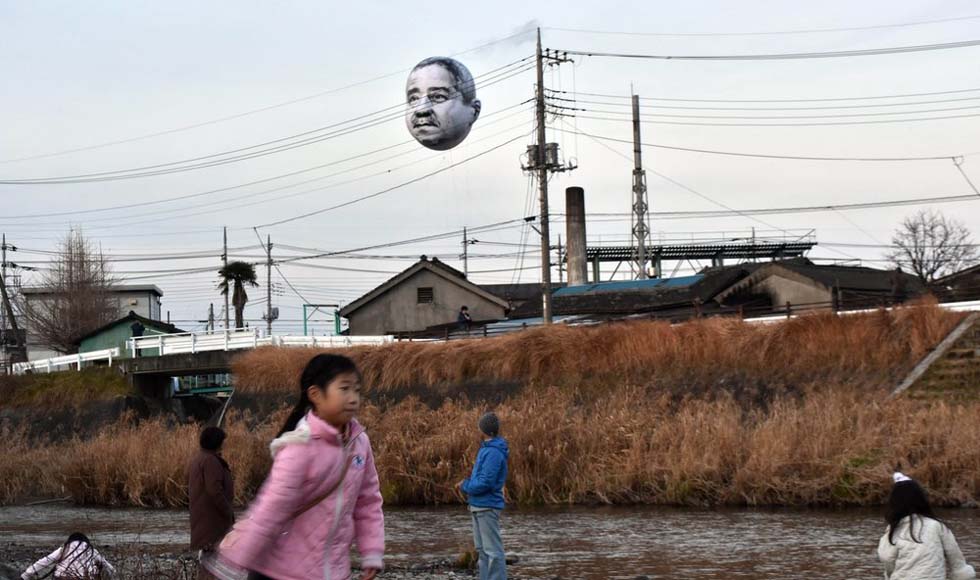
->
left=209, top=354, right=384, bottom=580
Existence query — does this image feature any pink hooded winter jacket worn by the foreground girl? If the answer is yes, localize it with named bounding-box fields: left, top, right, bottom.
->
left=215, top=413, right=384, bottom=580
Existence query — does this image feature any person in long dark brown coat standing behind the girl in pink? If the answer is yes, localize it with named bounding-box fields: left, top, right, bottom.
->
left=187, top=427, right=235, bottom=580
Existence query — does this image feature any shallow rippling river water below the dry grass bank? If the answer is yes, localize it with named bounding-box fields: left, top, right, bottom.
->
left=0, top=505, right=980, bottom=580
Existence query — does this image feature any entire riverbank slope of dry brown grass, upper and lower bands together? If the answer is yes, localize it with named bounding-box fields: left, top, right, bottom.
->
left=0, top=308, right=980, bottom=507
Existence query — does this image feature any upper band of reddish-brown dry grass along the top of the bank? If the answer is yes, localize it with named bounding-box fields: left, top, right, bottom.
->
left=233, top=307, right=960, bottom=393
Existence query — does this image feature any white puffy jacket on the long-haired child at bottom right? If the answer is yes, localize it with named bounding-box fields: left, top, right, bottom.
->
left=878, top=516, right=977, bottom=580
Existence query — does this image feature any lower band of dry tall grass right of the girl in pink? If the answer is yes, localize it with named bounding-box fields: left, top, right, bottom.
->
left=372, top=387, right=980, bottom=505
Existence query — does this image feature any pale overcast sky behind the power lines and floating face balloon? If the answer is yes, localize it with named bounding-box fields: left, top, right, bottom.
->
left=0, top=0, right=980, bottom=332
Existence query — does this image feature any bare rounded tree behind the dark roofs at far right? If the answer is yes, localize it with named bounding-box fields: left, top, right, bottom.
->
left=888, top=209, right=978, bottom=283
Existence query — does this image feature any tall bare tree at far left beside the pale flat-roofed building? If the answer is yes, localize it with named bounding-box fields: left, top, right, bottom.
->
left=22, top=230, right=120, bottom=354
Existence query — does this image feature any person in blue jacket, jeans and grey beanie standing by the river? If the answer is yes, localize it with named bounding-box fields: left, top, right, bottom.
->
left=459, top=413, right=510, bottom=580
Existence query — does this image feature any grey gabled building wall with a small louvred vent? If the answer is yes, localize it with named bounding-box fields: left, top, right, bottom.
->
left=348, top=270, right=504, bottom=336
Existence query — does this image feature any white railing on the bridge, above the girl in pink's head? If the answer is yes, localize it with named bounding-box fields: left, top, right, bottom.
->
left=127, top=329, right=395, bottom=357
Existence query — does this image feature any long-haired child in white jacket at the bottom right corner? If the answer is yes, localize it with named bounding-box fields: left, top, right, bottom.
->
left=878, top=472, right=977, bottom=580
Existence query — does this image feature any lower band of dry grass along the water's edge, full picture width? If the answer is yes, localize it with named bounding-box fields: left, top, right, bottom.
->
left=0, top=386, right=980, bottom=507
